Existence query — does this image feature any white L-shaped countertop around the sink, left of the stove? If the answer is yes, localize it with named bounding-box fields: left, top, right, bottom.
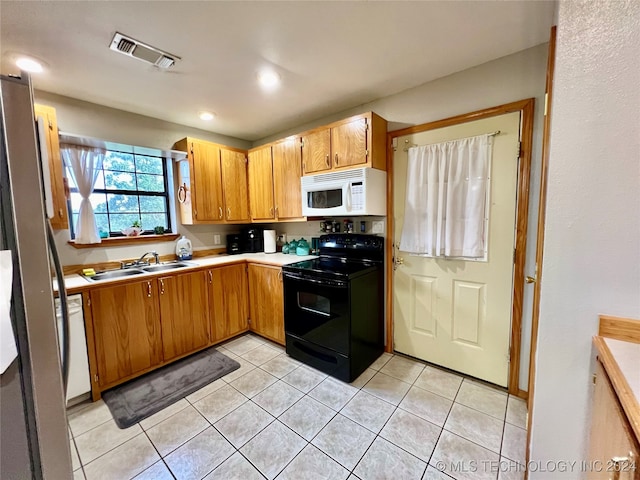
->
left=53, top=253, right=317, bottom=293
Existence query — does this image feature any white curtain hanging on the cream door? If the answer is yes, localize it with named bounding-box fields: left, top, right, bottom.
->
left=400, top=134, right=493, bottom=258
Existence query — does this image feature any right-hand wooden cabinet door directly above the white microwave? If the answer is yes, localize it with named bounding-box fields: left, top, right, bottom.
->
left=331, top=118, right=367, bottom=168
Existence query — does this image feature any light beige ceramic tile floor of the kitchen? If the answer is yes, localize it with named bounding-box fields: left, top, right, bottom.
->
left=69, top=334, right=526, bottom=480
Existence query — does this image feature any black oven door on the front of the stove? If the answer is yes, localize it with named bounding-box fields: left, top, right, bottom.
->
left=284, top=272, right=350, bottom=355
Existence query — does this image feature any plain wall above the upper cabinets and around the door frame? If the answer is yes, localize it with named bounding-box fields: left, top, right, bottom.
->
left=254, top=44, right=548, bottom=391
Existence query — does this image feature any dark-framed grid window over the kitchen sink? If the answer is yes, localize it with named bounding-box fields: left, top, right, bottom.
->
left=67, top=150, right=171, bottom=238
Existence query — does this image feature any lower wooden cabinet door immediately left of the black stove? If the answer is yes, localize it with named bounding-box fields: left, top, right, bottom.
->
left=249, top=264, right=284, bottom=344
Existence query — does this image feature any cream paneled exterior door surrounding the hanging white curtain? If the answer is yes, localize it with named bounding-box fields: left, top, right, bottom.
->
left=393, top=112, right=520, bottom=386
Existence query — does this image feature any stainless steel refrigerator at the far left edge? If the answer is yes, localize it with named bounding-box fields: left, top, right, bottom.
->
left=0, top=74, right=72, bottom=480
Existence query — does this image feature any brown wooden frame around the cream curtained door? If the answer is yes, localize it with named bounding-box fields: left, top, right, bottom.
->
left=385, top=98, right=535, bottom=399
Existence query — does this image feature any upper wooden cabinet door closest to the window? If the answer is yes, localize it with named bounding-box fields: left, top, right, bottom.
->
left=190, top=140, right=224, bottom=222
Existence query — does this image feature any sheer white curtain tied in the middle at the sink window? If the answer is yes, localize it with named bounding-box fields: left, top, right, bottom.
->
left=60, top=145, right=105, bottom=243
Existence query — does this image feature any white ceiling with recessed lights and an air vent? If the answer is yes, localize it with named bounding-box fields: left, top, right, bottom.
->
left=0, top=0, right=555, bottom=141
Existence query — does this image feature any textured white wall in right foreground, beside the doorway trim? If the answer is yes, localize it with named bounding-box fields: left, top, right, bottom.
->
left=529, top=0, right=640, bottom=474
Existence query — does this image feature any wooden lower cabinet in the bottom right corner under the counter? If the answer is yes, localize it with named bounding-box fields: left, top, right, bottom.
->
left=587, top=361, right=640, bottom=480
